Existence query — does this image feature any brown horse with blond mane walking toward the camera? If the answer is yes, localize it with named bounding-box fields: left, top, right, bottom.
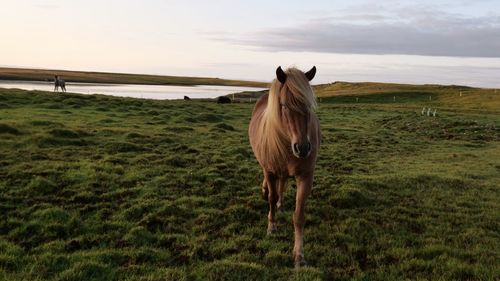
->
left=248, top=66, right=321, bottom=267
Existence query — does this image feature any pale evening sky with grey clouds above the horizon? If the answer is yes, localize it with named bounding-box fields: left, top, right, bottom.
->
left=0, top=0, right=500, bottom=87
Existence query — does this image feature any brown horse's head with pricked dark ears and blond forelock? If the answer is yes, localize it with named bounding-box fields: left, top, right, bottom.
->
left=276, top=66, right=316, bottom=158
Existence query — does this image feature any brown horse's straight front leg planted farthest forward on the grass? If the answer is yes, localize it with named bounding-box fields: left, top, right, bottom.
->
left=293, top=174, right=313, bottom=268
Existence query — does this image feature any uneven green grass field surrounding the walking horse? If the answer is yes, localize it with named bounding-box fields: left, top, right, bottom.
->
left=0, top=84, right=500, bottom=280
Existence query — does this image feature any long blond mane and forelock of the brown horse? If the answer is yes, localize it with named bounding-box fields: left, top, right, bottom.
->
left=257, top=67, right=317, bottom=172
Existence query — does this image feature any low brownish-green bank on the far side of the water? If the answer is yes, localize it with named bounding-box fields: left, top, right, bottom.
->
left=0, top=67, right=267, bottom=87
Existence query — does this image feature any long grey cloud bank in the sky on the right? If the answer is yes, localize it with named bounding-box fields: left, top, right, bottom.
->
left=212, top=7, right=500, bottom=57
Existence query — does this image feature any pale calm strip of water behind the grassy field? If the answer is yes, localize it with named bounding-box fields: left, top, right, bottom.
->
left=0, top=80, right=265, bottom=100
